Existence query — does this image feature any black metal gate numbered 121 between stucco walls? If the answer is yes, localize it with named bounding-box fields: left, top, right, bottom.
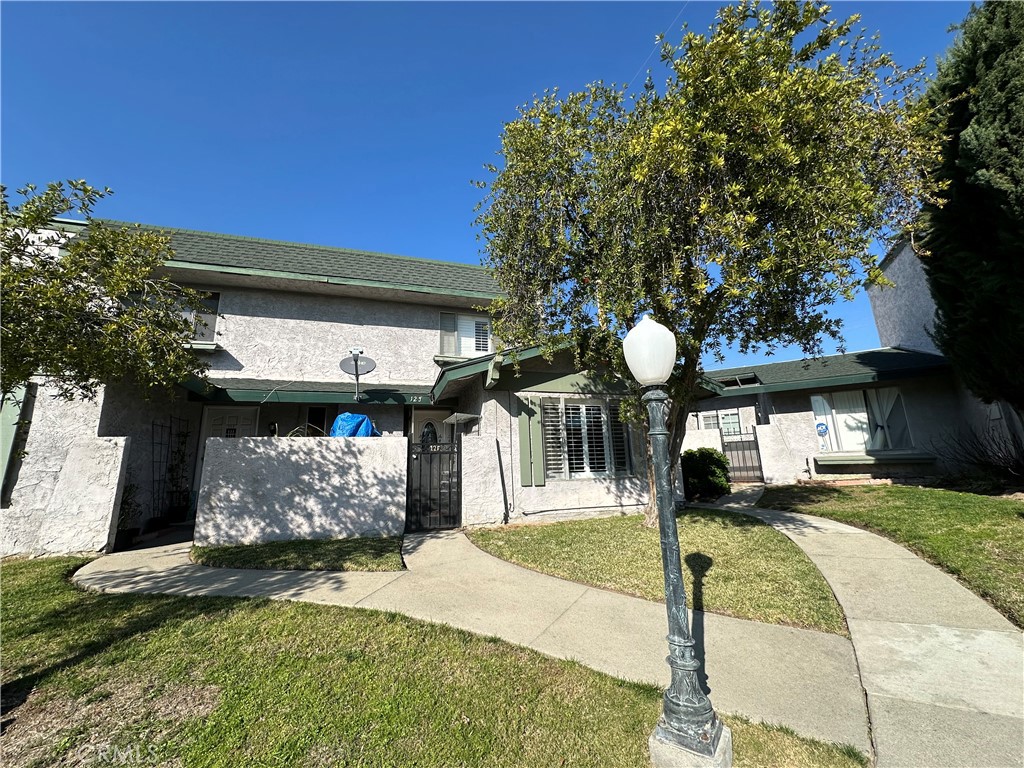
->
left=406, top=442, right=462, bottom=531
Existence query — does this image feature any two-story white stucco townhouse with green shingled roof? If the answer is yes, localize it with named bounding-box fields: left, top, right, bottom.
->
left=3, top=219, right=679, bottom=554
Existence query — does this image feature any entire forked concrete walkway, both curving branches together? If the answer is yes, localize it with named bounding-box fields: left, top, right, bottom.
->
left=75, top=505, right=1024, bottom=768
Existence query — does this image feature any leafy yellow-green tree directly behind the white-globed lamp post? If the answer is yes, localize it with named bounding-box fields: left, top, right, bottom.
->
left=476, top=0, right=935, bottom=520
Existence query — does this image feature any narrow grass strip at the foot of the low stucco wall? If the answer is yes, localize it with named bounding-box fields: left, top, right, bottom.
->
left=191, top=537, right=406, bottom=570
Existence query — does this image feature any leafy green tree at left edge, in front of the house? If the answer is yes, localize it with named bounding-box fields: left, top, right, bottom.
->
left=0, top=181, right=206, bottom=399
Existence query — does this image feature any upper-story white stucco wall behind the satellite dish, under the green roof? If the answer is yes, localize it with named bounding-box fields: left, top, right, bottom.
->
left=193, top=287, right=468, bottom=387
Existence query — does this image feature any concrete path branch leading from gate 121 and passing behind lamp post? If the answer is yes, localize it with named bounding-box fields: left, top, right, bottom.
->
left=74, top=532, right=870, bottom=753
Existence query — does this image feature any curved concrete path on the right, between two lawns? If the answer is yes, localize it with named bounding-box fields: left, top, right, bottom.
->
left=697, top=500, right=1024, bottom=768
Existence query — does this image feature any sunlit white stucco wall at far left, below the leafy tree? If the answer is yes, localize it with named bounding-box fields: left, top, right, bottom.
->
left=2, top=386, right=127, bottom=555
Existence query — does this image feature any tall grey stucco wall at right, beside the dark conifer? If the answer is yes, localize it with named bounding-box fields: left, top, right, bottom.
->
left=867, top=244, right=938, bottom=353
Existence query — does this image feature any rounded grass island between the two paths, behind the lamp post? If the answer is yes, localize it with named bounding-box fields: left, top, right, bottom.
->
left=467, top=509, right=847, bottom=636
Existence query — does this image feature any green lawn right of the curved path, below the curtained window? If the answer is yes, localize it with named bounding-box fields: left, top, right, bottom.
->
left=758, top=485, right=1024, bottom=627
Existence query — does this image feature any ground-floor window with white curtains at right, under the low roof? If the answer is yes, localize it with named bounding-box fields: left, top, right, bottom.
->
left=811, top=387, right=913, bottom=454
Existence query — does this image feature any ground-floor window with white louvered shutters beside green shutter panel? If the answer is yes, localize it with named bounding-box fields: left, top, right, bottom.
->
left=541, top=397, right=633, bottom=479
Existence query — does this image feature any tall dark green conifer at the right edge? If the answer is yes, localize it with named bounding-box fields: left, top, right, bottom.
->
left=922, top=2, right=1024, bottom=415
